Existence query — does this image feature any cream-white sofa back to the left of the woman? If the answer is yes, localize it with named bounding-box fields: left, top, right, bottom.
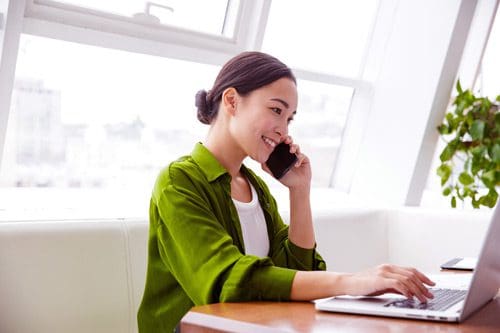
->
left=0, top=220, right=148, bottom=333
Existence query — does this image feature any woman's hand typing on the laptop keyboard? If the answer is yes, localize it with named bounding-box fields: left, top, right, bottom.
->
left=344, top=264, right=435, bottom=302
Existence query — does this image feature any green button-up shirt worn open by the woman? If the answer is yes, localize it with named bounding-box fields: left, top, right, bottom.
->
left=137, top=143, right=326, bottom=333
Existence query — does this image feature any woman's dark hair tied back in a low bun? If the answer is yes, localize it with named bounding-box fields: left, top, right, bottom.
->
left=195, top=51, right=297, bottom=124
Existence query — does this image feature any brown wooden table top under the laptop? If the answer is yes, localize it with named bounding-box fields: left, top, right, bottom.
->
left=181, top=297, right=500, bottom=333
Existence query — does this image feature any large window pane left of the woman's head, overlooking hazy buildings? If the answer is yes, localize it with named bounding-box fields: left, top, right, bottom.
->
left=0, top=35, right=219, bottom=213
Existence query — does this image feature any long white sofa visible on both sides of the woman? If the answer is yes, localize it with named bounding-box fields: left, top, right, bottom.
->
left=0, top=208, right=491, bottom=333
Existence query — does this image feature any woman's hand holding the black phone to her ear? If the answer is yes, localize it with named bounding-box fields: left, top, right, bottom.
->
left=262, top=136, right=312, bottom=189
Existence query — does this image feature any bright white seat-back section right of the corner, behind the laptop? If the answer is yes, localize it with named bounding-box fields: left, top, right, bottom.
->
left=387, top=208, right=492, bottom=272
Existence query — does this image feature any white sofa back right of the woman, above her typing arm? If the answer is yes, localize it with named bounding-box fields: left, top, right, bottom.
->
left=313, top=207, right=493, bottom=273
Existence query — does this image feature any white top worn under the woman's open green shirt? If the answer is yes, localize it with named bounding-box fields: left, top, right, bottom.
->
left=233, top=184, right=269, bottom=257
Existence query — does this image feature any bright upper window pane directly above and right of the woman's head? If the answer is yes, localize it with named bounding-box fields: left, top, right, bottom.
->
left=263, top=0, right=378, bottom=77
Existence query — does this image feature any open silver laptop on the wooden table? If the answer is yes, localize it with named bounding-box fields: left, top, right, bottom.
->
left=315, top=205, right=500, bottom=322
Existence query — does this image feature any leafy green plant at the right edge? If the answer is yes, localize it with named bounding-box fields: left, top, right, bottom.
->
left=437, top=81, right=500, bottom=208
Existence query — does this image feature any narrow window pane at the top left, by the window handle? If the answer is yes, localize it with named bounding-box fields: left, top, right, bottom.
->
left=36, top=0, right=239, bottom=37
